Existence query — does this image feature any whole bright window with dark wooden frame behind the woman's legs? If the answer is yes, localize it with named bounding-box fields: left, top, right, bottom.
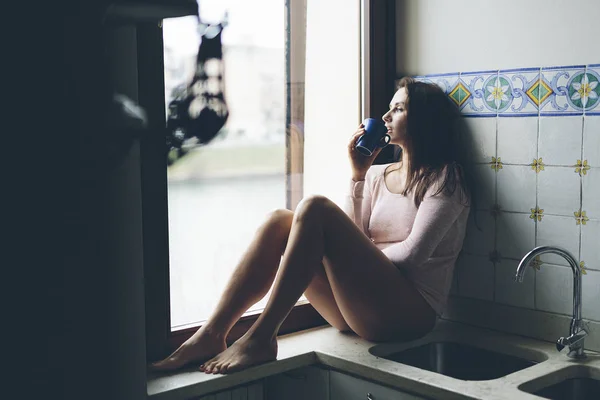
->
left=144, top=0, right=395, bottom=360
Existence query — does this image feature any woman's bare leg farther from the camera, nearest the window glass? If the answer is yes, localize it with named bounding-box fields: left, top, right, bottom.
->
left=151, top=210, right=293, bottom=371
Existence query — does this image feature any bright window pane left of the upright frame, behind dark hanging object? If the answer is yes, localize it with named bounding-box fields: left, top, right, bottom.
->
left=163, top=0, right=304, bottom=329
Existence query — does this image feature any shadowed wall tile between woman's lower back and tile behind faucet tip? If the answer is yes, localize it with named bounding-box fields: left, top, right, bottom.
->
left=456, top=254, right=494, bottom=301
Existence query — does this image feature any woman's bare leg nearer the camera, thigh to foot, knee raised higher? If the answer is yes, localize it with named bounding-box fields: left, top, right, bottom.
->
left=201, top=196, right=435, bottom=373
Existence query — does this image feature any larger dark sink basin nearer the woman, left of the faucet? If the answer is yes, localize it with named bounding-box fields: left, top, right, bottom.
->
left=380, top=342, right=537, bottom=381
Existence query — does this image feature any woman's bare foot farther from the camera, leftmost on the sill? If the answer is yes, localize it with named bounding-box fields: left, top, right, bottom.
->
left=149, top=327, right=227, bottom=371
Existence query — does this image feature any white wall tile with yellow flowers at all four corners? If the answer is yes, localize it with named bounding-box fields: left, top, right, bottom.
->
left=538, top=167, right=581, bottom=216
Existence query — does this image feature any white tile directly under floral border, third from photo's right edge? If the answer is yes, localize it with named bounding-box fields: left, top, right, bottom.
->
left=498, top=117, right=538, bottom=164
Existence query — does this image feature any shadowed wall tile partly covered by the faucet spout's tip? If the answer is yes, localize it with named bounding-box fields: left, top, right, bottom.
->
left=494, top=259, right=535, bottom=309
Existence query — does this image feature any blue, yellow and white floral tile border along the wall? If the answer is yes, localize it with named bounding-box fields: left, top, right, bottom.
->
left=415, top=64, right=600, bottom=117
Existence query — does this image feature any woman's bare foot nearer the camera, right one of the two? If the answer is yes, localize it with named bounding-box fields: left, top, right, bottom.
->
left=200, top=336, right=277, bottom=374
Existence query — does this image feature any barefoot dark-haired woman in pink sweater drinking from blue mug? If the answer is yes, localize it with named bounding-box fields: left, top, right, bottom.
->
left=151, top=78, right=470, bottom=373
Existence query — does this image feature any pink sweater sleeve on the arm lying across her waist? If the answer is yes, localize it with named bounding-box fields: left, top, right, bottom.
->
left=383, top=184, right=468, bottom=268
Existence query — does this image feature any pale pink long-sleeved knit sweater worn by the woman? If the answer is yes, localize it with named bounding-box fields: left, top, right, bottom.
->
left=344, top=164, right=470, bottom=316
